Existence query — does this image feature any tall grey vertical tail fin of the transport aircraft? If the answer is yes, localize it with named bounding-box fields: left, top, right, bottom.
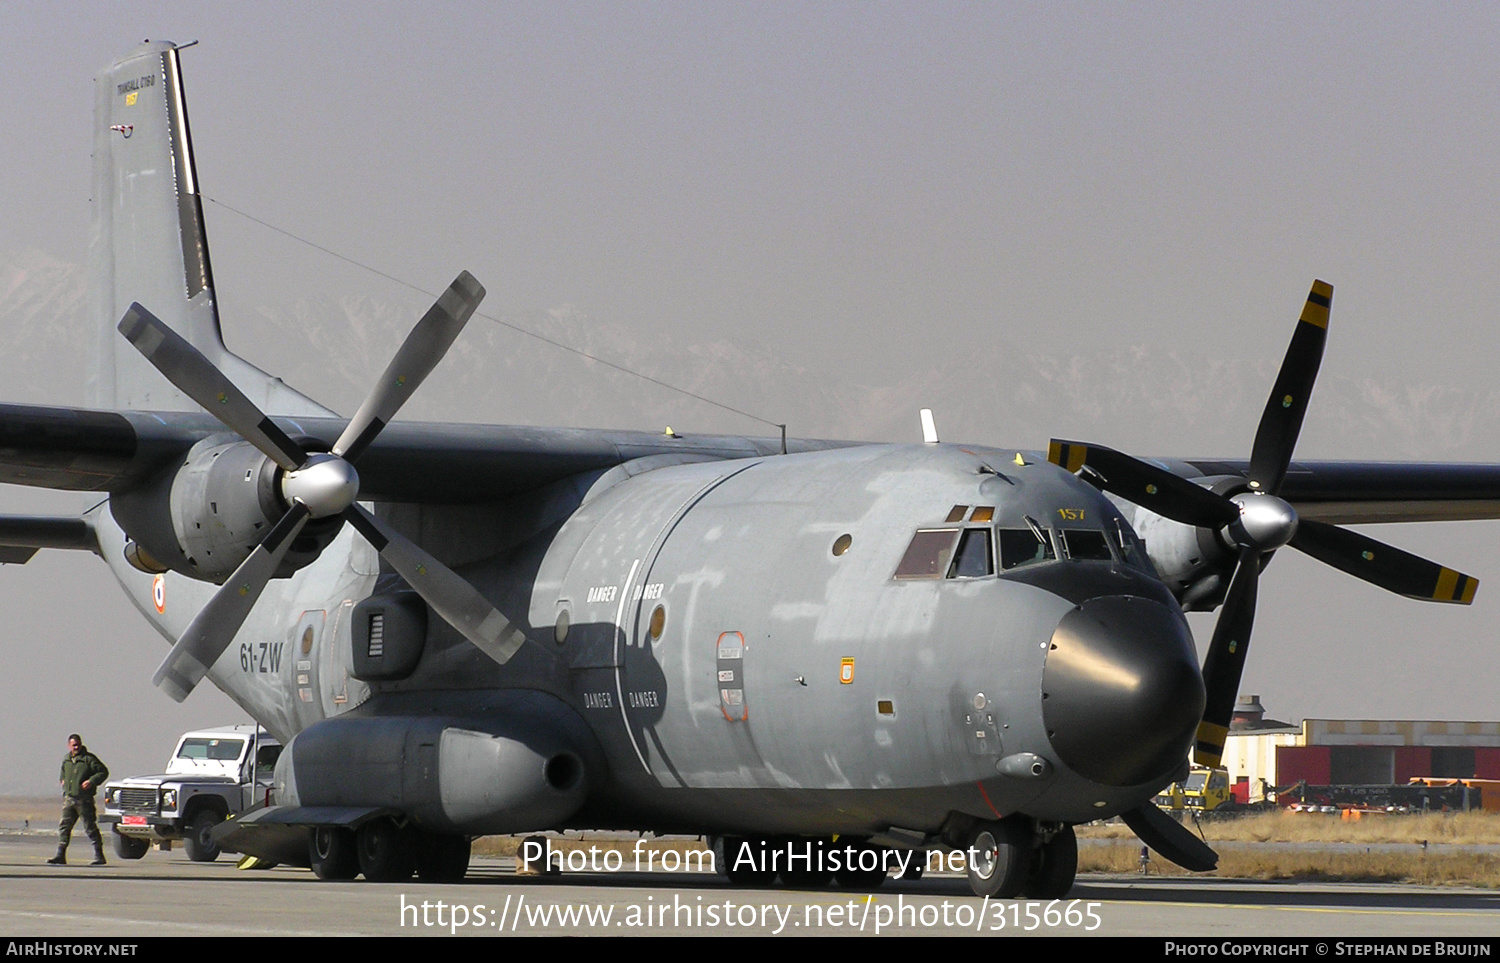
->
left=89, top=41, right=329, bottom=414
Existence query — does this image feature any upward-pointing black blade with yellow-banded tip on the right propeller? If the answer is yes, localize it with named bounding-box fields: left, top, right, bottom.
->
left=1250, top=281, right=1334, bottom=495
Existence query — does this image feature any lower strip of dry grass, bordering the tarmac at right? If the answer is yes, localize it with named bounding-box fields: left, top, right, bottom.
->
left=1079, top=842, right=1500, bottom=888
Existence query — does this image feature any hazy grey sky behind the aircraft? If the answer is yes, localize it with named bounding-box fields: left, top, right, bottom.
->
left=0, top=0, right=1500, bottom=789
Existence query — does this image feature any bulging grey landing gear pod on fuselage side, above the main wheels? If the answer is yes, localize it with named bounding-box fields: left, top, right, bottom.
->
left=276, top=690, right=603, bottom=834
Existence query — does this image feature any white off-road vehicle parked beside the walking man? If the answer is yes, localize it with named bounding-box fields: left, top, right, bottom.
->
left=99, top=726, right=282, bottom=863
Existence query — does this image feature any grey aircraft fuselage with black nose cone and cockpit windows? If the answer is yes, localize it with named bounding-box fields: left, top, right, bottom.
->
left=96, top=446, right=1202, bottom=834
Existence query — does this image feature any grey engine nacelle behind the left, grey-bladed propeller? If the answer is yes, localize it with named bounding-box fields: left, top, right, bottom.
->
left=110, top=435, right=341, bottom=582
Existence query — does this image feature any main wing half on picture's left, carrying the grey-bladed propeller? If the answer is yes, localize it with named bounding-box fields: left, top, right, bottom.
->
left=0, top=405, right=849, bottom=504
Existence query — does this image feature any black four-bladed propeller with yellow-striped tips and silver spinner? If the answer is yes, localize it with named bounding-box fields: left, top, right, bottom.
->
left=1049, top=273, right=1479, bottom=768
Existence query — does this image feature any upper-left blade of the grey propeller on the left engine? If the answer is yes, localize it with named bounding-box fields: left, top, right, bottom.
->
left=119, top=305, right=308, bottom=471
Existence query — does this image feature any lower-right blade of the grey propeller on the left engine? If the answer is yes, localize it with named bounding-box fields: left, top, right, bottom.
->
left=344, top=504, right=527, bottom=665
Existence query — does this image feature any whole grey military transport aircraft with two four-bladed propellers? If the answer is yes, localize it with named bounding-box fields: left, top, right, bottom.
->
left=0, top=42, right=1500, bottom=897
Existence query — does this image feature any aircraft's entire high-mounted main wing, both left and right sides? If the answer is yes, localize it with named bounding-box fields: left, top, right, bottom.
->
left=11, top=405, right=1500, bottom=525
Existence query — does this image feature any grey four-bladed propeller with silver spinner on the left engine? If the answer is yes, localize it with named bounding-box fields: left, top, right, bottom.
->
left=120, top=272, right=524, bottom=702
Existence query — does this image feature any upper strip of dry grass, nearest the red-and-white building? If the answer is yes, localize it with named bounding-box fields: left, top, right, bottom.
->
left=1079, top=812, right=1500, bottom=846
